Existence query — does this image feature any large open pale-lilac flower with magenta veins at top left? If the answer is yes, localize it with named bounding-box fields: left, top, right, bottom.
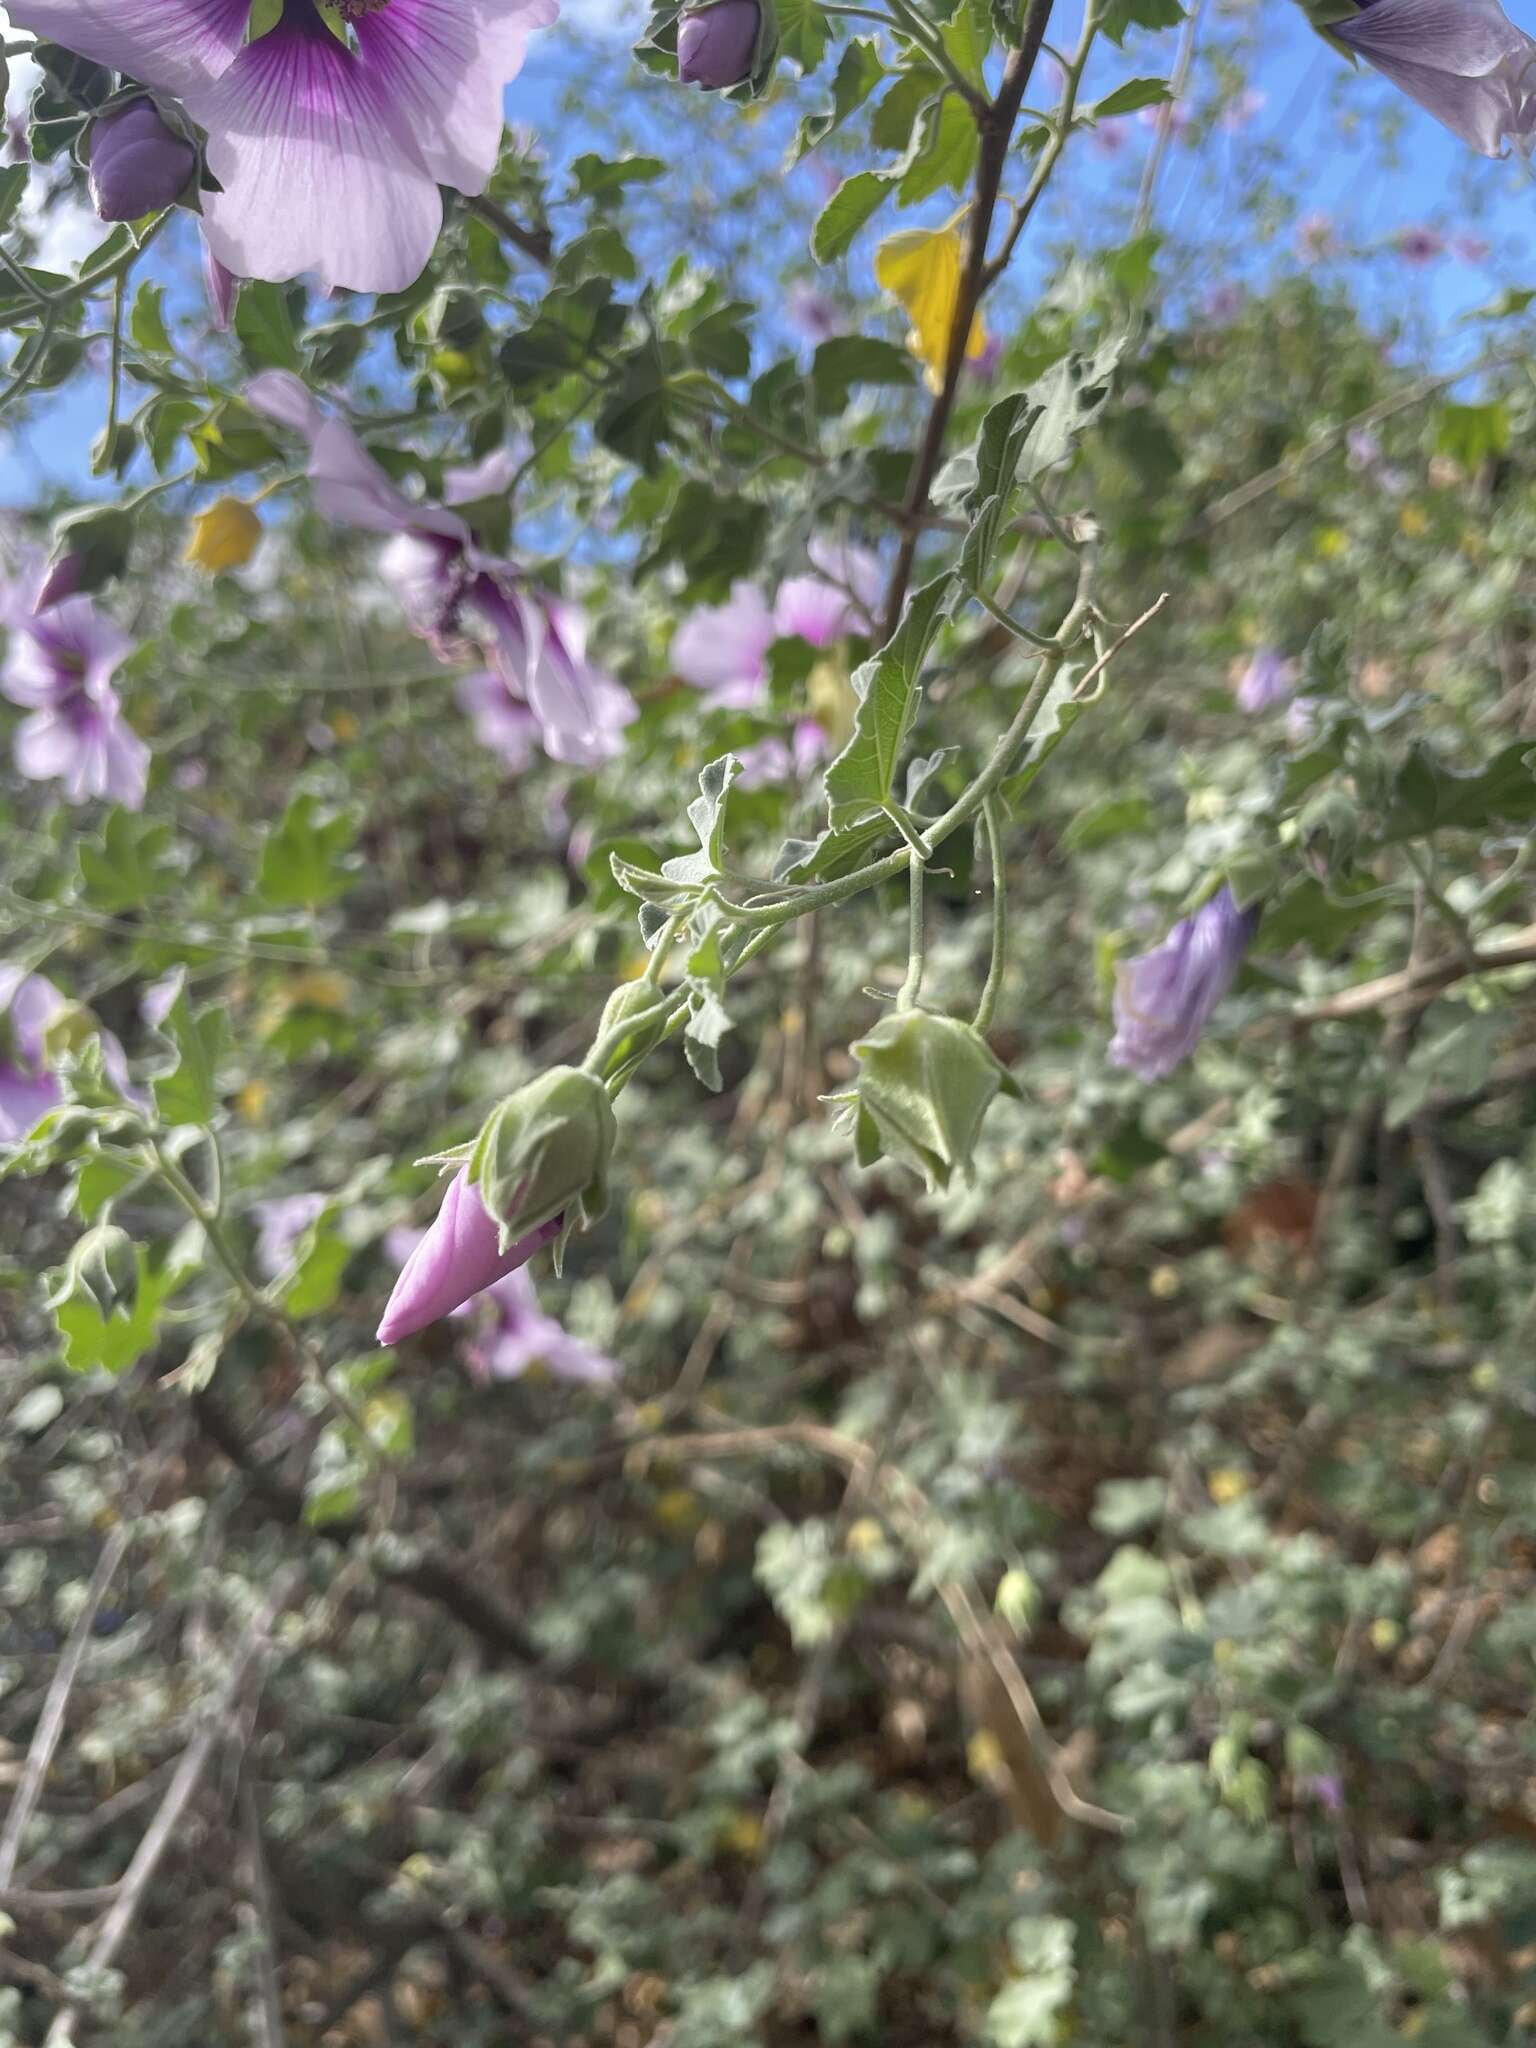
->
left=10, top=0, right=559, bottom=291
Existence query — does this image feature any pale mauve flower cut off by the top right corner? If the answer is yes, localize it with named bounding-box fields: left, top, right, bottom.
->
left=1331, top=0, right=1536, bottom=156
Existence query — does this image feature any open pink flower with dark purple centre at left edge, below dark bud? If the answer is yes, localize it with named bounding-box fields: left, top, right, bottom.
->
left=0, top=563, right=150, bottom=811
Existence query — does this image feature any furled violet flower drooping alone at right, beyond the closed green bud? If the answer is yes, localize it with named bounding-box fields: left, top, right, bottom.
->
left=1110, top=883, right=1260, bottom=1081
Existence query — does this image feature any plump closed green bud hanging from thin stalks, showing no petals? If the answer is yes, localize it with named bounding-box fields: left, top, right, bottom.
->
left=854, top=1010, right=1018, bottom=1188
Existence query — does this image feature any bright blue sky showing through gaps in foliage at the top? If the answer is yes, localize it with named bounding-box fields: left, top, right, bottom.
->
left=0, top=0, right=1536, bottom=504
